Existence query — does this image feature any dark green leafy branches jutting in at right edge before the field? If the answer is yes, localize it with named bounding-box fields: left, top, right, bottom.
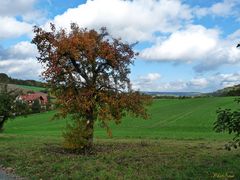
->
left=214, top=103, right=240, bottom=150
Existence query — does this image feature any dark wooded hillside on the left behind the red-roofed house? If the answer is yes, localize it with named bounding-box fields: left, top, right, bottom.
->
left=0, top=73, right=45, bottom=88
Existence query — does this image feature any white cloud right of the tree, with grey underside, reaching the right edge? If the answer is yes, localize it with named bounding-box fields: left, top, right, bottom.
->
left=140, top=25, right=240, bottom=72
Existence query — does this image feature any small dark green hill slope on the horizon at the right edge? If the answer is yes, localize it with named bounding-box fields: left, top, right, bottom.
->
left=211, top=84, right=240, bottom=96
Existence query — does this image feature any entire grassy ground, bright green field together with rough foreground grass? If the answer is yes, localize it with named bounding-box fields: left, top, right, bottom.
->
left=0, top=97, right=240, bottom=179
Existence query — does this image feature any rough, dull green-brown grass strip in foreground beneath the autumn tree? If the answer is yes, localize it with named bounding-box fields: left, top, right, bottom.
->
left=0, top=135, right=240, bottom=179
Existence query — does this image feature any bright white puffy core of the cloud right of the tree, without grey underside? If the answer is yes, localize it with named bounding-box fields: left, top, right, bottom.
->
left=141, top=25, right=219, bottom=62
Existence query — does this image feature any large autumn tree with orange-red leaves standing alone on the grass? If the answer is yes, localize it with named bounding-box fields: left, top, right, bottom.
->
left=32, top=23, right=150, bottom=149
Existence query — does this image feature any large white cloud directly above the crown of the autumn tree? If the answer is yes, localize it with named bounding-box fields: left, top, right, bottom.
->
left=46, top=0, right=192, bottom=41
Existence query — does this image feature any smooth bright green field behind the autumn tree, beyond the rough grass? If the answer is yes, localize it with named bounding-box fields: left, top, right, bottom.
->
left=5, top=97, right=237, bottom=139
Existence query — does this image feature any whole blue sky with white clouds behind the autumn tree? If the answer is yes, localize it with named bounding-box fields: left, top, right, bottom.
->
left=0, top=0, right=240, bottom=92
